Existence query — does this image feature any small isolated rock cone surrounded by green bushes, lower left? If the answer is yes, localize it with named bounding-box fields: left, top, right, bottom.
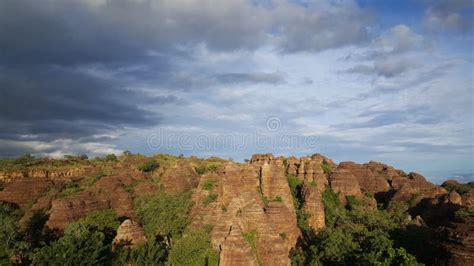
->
left=113, top=219, right=147, bottom=248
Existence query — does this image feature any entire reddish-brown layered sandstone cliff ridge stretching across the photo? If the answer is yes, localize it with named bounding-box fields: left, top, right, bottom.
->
left=0, top=154, right=474, bottom=265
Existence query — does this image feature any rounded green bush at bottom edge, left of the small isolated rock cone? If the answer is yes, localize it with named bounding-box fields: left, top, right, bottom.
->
left=32, top=224, right=111, bottom=265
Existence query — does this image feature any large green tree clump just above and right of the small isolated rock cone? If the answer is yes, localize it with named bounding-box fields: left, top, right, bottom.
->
left=135, top=189, right=191, bottom=239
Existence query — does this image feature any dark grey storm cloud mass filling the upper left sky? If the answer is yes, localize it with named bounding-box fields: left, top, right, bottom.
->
left=0, top=0, right=374, bottom=155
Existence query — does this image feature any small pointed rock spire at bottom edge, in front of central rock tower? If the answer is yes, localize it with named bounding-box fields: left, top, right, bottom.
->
left=219, top=224, right=258, bottom=266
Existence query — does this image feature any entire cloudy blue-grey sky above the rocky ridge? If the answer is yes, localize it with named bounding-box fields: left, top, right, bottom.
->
left=0, top=0, right=474, bottom=183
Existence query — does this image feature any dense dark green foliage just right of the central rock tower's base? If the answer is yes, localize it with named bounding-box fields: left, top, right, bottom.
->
left=292, top=190, right=418, bottom=265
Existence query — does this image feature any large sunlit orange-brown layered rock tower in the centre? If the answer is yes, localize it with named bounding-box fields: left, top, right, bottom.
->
left=191, top=158, right=300, bottom=265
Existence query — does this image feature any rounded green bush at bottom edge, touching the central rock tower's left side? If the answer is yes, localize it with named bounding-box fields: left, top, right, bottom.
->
left=168, top=230, right=219, bottom=266
